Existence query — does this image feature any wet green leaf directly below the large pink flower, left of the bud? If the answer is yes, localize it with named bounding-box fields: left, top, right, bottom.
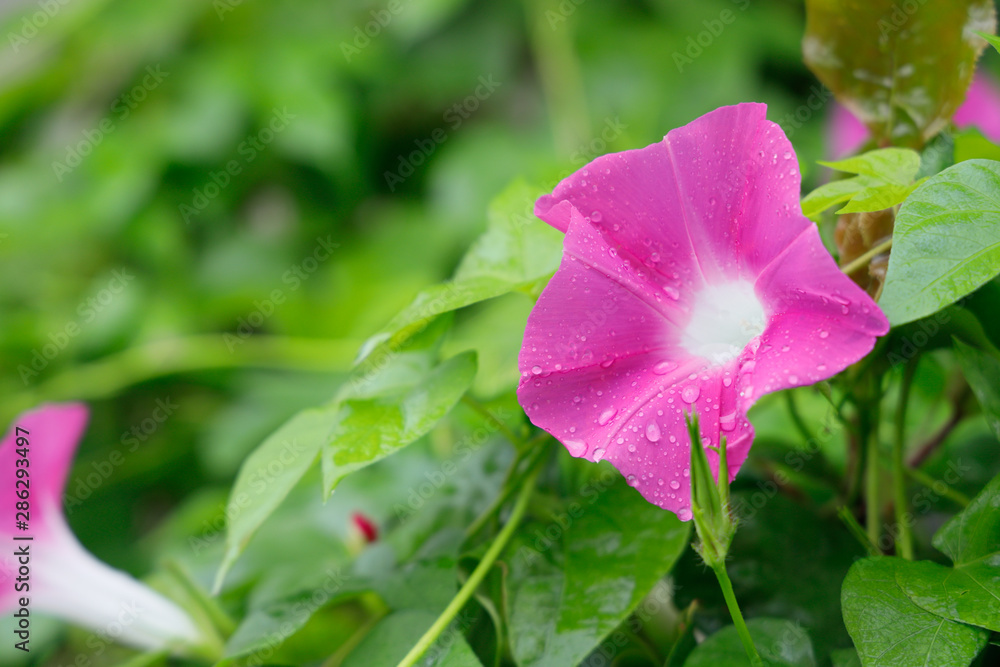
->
left=507, top=478, right=690, bottom=667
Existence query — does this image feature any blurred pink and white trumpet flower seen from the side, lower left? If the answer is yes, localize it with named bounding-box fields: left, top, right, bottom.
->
left=0, top=404, right=202, bottom=650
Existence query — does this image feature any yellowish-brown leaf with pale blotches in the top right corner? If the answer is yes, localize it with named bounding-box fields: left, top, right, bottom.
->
left=802, top=0, right=996, bottom=147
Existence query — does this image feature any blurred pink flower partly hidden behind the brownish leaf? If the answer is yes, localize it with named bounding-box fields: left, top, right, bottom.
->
left=827, top=74, right=1000, bottom=160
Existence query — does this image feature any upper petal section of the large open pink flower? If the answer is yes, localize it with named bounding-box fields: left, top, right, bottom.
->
left=535, top=103, right=808, bottom=290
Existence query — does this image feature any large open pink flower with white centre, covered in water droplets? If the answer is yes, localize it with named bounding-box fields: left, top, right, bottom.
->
left=518, top=104, right=889, bottom=520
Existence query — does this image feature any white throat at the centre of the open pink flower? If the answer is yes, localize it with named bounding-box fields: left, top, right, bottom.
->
left=681, top=280, right=767, bottom=365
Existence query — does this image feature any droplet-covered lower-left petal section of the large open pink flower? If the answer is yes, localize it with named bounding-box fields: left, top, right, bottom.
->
left=518, top=201, right=752, bottom=516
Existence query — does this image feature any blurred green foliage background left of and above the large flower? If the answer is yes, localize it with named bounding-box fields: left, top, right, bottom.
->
left=0, top=0, right=992, bottom=664
